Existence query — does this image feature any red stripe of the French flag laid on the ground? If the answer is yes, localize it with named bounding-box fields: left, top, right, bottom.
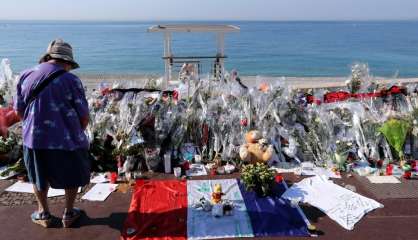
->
left=121, top=180, right=187, bottom=240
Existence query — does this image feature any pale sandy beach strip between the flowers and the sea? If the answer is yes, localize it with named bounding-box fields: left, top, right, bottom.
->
left=78, top=74, right=418, bottom=89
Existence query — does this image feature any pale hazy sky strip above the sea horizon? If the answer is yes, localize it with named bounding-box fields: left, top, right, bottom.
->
left=0, top=0, right=418, bottom=20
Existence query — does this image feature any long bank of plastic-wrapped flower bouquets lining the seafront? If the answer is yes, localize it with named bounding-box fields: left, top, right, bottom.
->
left=0, top=58, right=418, bottom=178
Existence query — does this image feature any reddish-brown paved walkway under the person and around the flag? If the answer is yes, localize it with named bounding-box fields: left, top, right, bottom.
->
left=0, top=175, right=418, bottom=240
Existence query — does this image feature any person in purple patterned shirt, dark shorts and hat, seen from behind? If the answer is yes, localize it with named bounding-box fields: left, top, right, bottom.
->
left=15, top=39, right=90, bottom=227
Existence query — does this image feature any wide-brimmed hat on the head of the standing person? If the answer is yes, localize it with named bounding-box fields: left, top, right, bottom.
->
left=39, top=39, right=80, bottom=69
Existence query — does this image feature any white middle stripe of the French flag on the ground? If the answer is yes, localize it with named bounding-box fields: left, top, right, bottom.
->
left=187, top=179, right=254, bottom=239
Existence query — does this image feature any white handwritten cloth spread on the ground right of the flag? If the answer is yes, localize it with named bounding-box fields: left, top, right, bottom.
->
left=282, top=176, right=383, bottom=230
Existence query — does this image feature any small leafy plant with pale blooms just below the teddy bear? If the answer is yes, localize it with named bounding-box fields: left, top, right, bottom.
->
left=241, top=163, right=275, bottom=197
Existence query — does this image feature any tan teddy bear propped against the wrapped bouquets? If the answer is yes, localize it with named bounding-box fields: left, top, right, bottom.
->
left=239, top=130, right=274, bottom=164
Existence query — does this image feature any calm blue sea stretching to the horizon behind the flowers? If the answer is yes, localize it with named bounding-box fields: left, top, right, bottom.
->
left=0, top=21, right=418, bottom=77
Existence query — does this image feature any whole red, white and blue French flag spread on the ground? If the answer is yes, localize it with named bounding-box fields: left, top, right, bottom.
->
left=121, top=179, right=310, bottom=240
